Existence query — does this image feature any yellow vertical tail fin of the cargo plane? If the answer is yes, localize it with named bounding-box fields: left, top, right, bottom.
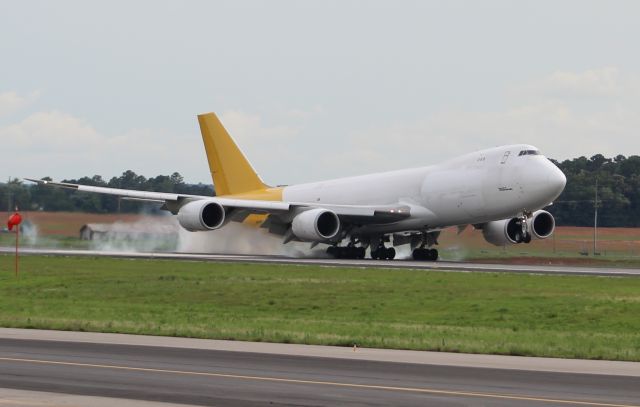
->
left=198, top=113, right=268, bottom=196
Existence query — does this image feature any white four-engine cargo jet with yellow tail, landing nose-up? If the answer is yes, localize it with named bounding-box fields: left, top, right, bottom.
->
left=29, top=113, right=566, bottom=260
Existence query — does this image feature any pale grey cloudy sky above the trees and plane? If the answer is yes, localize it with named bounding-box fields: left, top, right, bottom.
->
left=0, top=0, right=640, bottom=184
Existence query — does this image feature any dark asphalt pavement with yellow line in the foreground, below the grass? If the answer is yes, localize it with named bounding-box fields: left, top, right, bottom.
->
left=0, top=330, right=640, bottom=406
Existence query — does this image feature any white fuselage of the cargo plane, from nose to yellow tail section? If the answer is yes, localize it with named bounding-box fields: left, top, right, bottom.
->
left=283, top=144, right=566, bottom=233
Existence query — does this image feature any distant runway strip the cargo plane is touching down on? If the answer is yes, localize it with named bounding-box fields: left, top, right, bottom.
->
left=0, top=247, right=640, bottom=277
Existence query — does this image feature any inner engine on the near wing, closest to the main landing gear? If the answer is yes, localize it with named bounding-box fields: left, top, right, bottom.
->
left=291, top=208, right=340, bottom=242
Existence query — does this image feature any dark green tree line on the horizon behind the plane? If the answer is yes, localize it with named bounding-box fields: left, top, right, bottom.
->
left=0, top=154, right=640, bottom=227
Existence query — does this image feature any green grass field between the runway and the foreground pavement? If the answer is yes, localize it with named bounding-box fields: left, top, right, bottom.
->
left=0, top=256, right=640, bottom=361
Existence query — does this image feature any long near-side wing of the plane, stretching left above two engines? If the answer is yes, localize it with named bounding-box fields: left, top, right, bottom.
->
left=25, top=178, right=410, bottom=224
